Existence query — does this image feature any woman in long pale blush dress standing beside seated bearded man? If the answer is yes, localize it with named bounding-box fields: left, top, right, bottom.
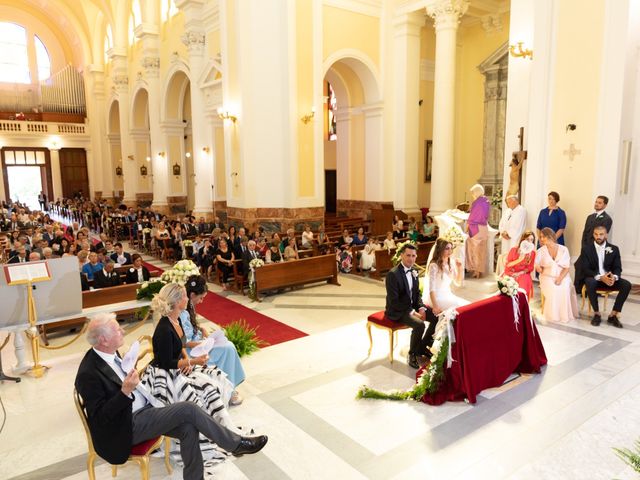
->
left=536, top=227, right=578, bottom=322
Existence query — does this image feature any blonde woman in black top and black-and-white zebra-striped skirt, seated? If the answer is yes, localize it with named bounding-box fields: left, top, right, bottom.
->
left=141, top=283, right=237, bottom=458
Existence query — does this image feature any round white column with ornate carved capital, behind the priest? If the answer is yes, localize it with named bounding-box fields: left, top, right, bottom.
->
left=426, top=0, right=469, bottom=214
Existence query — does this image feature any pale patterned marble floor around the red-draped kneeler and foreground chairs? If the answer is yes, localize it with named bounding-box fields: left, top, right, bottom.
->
left=0, top=258, right=640, bottom=480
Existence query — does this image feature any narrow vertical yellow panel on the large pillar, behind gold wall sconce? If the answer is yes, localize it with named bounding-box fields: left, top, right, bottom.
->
left=295, top=0, right=314, bottom=197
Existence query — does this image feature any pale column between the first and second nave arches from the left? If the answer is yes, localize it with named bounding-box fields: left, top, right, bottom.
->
left=109, top=48, right=136, bottom=206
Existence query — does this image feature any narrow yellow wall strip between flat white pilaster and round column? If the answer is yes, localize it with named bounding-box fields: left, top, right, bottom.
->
left=418, top=25, right=436, bottom=208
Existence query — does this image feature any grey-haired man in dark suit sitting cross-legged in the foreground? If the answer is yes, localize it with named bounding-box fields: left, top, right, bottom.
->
left=75, top=313, right=267, bottom=480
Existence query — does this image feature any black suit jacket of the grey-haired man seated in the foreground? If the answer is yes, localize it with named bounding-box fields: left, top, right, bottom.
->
left=75, top=349, right=133, bottom=465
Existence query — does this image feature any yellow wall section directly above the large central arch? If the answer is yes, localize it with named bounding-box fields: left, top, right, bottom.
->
left=322, top=5, right=380, bottom=66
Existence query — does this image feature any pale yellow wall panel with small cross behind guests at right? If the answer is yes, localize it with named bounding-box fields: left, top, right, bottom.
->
left=548, top=0, right=605, bottom=255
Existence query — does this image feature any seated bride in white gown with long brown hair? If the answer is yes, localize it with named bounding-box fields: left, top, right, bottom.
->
left=425, top=238, right=469, bottom=315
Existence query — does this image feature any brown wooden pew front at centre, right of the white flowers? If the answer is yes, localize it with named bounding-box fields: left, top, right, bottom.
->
left=255, top=255, right=340, bottom=293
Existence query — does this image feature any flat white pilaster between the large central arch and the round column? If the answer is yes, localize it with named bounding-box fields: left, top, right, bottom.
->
left=393, top=12, right=424, bottom=213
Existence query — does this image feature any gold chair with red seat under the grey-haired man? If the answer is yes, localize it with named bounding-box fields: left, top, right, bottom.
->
left=73, top=389, right=171, bottom=480
